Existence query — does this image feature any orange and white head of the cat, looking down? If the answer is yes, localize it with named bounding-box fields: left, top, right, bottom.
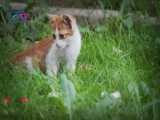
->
left=49, top=15, right=75, bottom=48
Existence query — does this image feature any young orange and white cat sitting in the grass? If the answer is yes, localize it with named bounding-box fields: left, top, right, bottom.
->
left=13, top=15, right=81, bottom=75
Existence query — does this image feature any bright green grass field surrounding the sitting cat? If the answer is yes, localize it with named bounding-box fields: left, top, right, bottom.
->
left=0, top=18, right=160, bottom=120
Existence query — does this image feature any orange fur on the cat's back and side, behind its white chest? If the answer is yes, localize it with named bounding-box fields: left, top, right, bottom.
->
left=11, top=37, right=54, bottom=72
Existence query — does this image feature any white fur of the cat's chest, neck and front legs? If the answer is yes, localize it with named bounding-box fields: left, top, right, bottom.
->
left=46, top=21, right=81, bottom=75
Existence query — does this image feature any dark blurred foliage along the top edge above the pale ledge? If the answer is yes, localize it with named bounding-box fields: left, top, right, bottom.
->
left=10, top=0, right=160, bottom=16
